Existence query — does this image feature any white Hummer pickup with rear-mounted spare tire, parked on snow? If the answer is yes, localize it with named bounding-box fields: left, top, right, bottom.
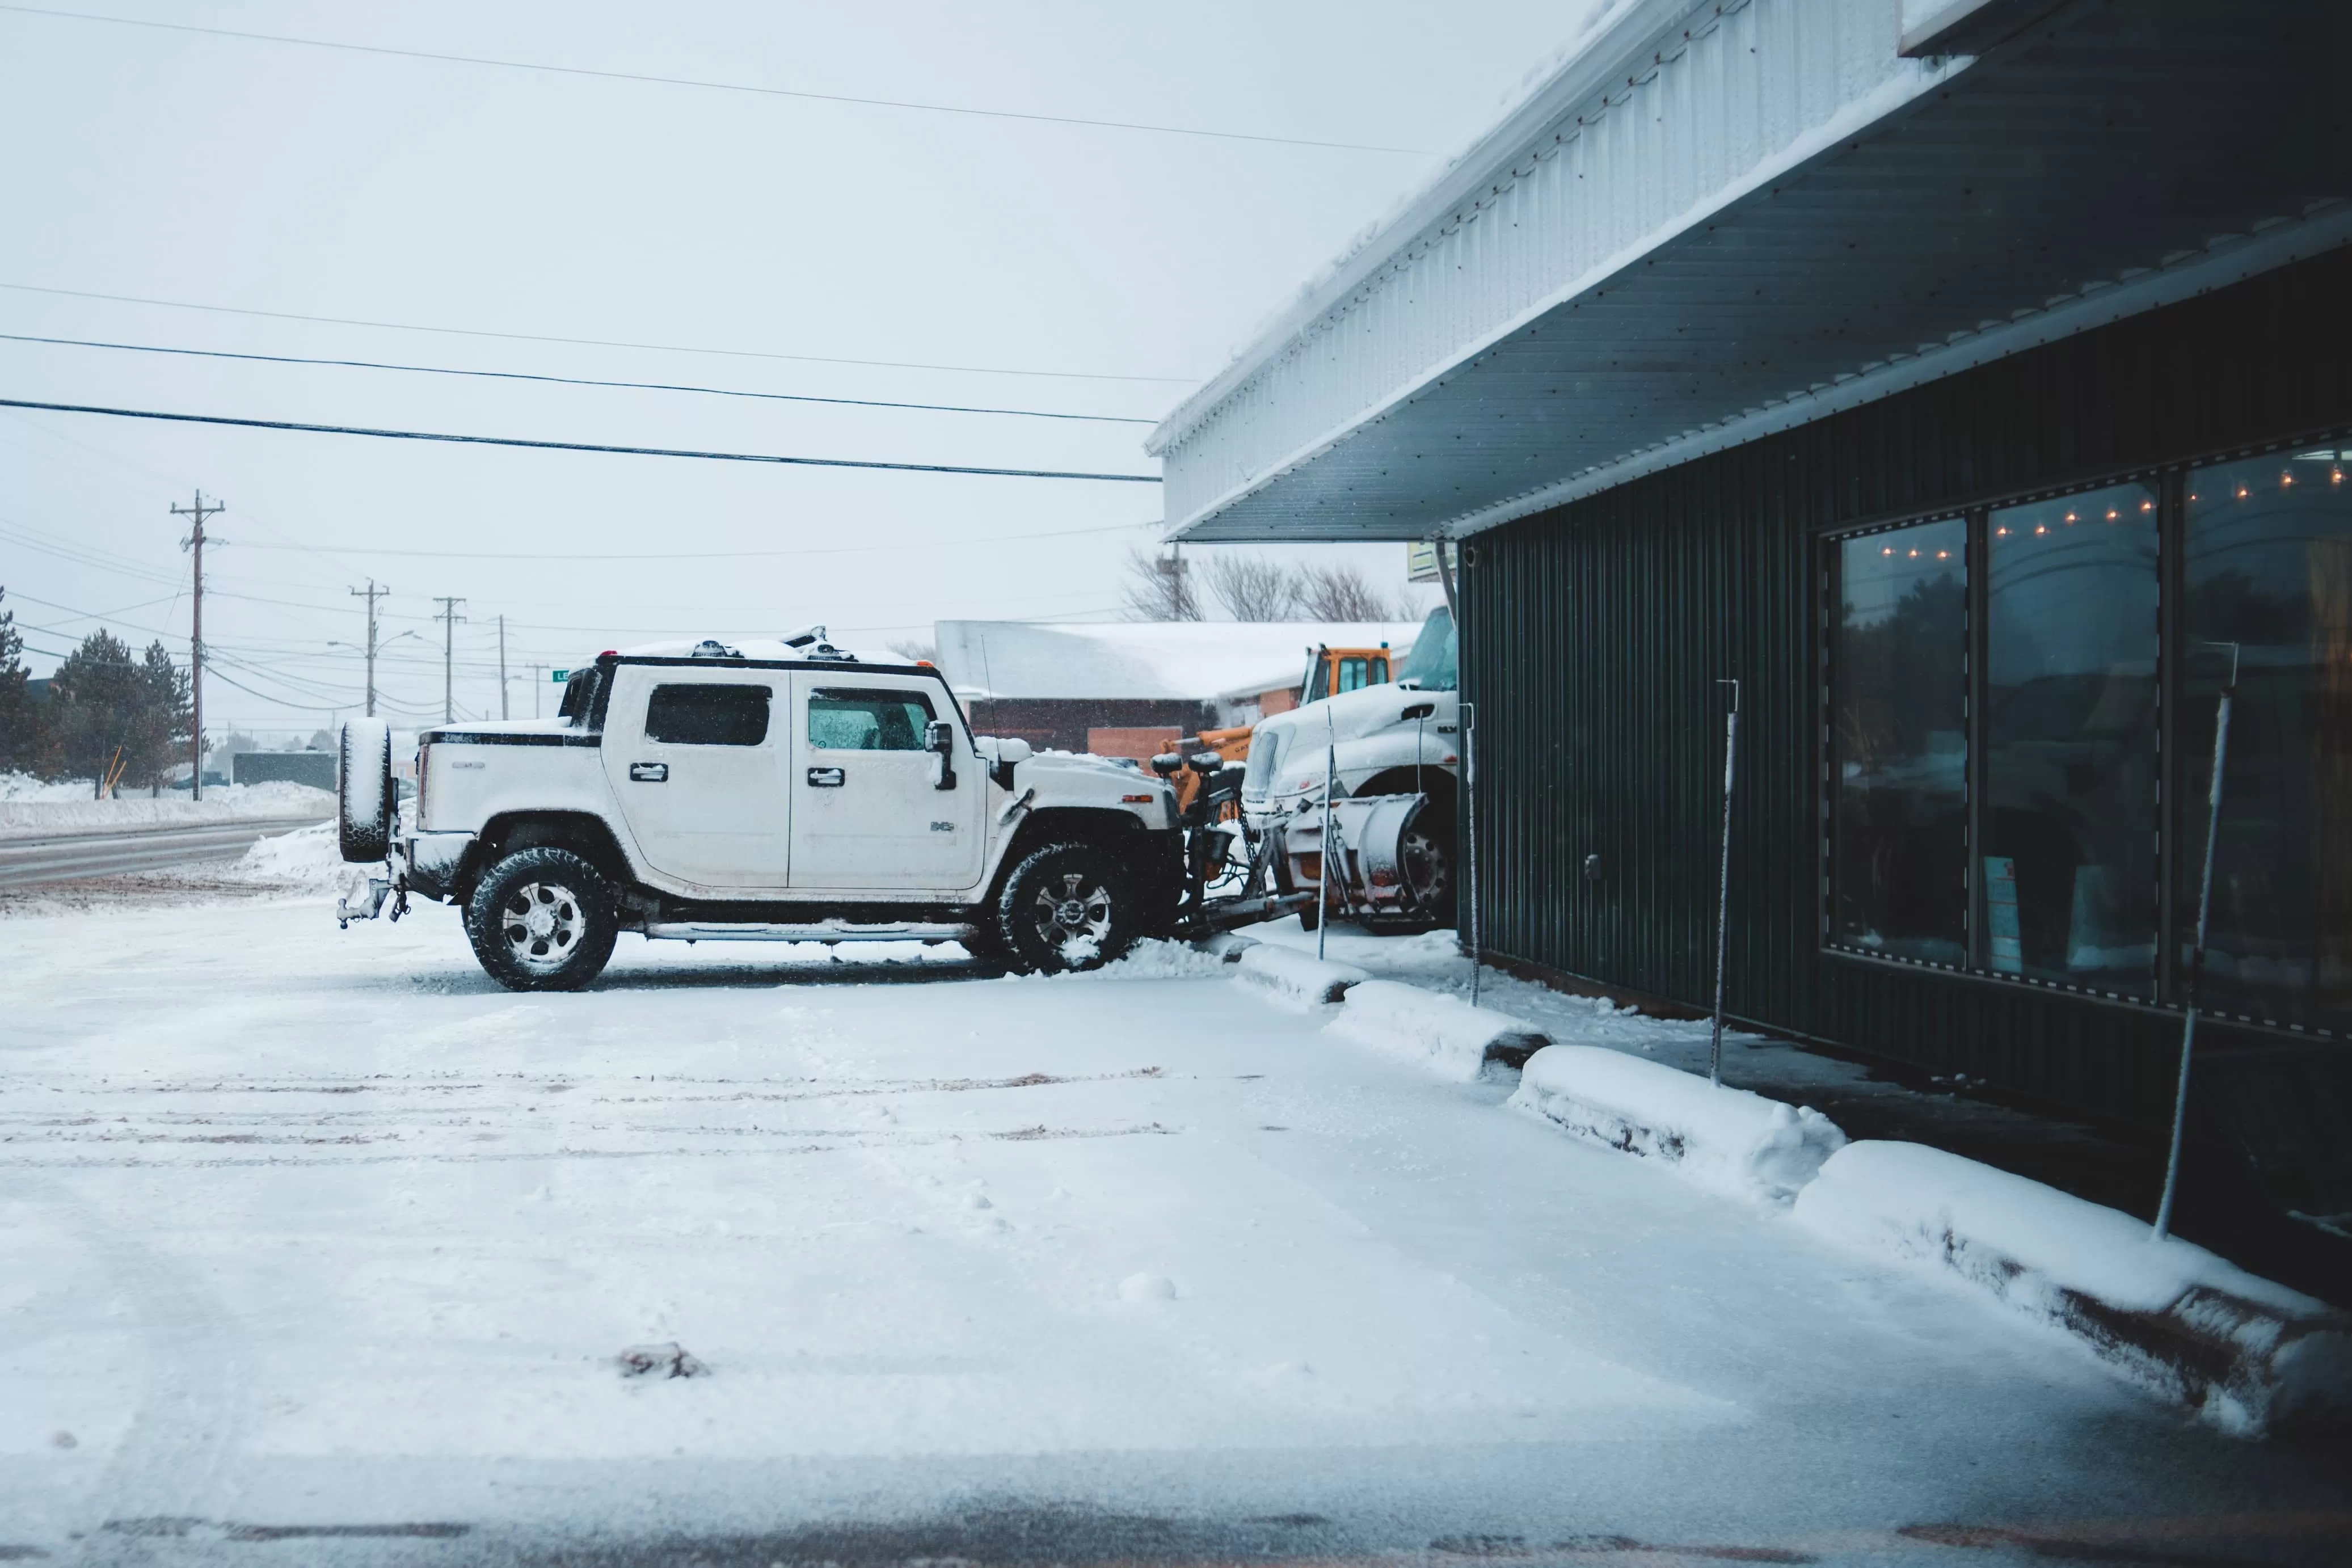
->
left=341, top=627, right=1204, bottom=990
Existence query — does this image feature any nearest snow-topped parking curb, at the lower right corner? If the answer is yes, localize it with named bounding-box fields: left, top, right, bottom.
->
left=1797, top=1143, right=2352, bottom=1436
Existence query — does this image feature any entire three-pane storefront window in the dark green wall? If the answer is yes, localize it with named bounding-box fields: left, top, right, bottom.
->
left=1820, top=437, right=2352, bottom=1034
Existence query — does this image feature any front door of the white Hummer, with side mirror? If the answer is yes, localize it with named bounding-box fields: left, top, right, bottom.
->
left=793, top=670, right=985, bottom=893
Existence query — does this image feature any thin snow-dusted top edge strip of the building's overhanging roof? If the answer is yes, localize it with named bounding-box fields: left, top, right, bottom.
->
left=1143, top=0, right=1712, bottom=456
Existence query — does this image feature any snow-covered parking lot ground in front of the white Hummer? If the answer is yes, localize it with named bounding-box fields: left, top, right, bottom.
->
left=0, top=879, right=2347, bottom=1563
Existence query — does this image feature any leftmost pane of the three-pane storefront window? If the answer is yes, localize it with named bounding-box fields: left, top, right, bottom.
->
left=1830, top=517, right=1969, bottom=964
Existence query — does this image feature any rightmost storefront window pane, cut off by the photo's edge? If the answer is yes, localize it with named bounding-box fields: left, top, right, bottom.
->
left=2173, top=446, right=2352, bottom=1030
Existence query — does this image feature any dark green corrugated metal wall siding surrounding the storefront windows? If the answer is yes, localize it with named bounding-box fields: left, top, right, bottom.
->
left=1463, top=251, right=2352, bottom=1122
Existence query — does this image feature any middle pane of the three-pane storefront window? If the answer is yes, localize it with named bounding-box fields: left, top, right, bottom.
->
left=1978, top=482, right=2159, bottom=994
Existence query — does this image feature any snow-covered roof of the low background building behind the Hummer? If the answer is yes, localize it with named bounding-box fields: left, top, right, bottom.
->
left=938, top=621, right=1421, bottom=701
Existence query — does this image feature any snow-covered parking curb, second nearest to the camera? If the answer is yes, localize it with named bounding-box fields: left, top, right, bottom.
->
left=1510, top=1046, right=1847, bottom=1206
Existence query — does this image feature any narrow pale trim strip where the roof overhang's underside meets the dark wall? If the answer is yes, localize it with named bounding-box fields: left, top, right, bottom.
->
left=1439, top=202, right=2352, bottom=538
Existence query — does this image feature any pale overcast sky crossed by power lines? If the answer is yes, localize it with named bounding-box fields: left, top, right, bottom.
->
left=0, top=0, right=1590, bottom=729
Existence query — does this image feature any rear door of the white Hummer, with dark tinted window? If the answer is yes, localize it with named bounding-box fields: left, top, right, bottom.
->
left=605, top=665, right=793, bottom=891
